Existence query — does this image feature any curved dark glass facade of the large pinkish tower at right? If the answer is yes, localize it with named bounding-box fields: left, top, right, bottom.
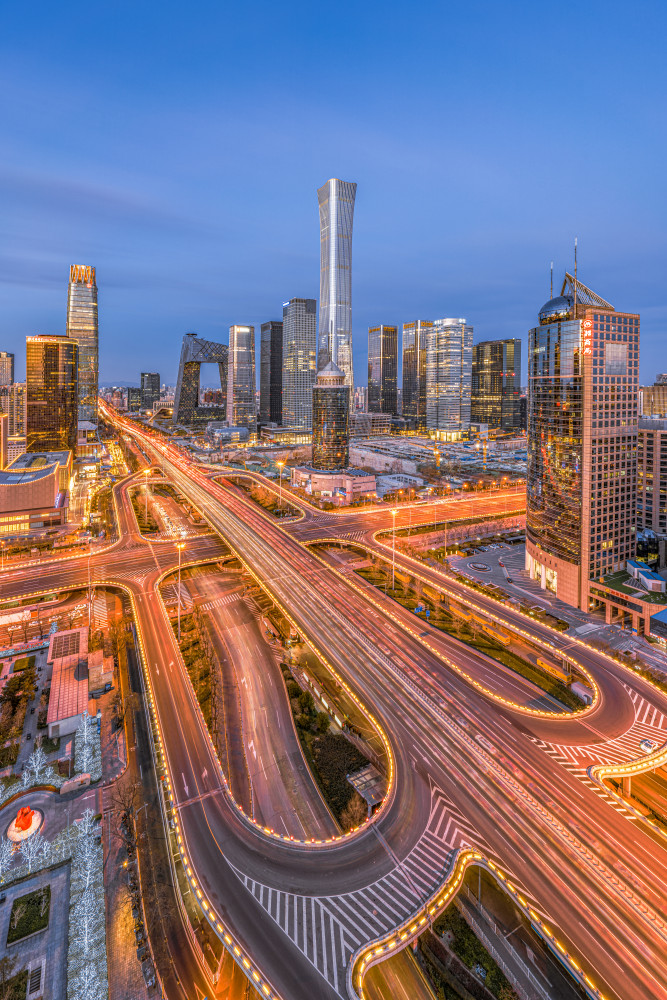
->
left=526, top=320, right=583, bottom=564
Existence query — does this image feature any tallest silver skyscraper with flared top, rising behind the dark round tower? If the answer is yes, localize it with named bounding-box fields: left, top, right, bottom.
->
left=317, top=178, right=357, bottom=390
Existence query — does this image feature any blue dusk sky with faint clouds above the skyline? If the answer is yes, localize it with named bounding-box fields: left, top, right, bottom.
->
left=0, top=0, right=667, bottom=384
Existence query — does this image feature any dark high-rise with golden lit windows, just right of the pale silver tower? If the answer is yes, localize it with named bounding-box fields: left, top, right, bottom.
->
left=470, top=340, right=521, bottom=433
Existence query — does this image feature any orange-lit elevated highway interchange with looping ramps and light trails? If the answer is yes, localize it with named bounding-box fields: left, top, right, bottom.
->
left=5, top=406, right=667, bottom=1000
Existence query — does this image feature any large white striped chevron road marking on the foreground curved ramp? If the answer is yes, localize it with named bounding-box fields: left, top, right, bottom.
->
left=232, top=786, right=488, bottom=997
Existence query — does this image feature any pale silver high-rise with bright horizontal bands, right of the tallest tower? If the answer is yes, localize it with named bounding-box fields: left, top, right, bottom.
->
left=426, top=319, right=472, bottom=435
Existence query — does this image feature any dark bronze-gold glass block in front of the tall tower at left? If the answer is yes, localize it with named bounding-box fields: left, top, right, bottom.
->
left=26, top=335, right=79, bottom=454
